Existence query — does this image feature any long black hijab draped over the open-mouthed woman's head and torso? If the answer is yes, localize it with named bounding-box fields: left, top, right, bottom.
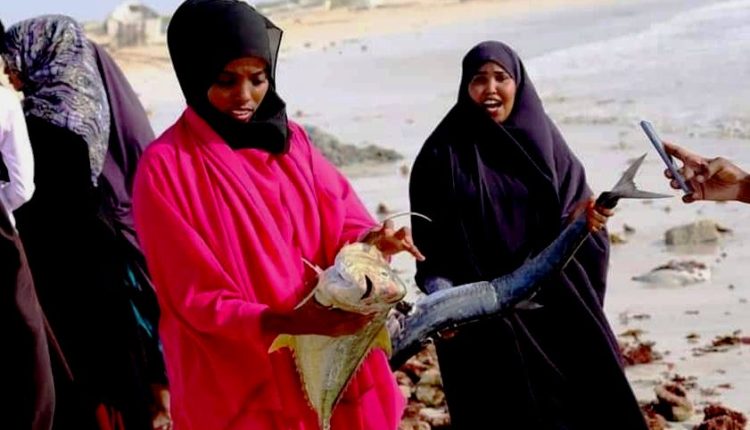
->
left=410, top=41, right=603, bottom=288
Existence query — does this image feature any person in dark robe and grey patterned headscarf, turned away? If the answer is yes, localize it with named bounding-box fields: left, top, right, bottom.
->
left=2, top=15, right=169, bottom=430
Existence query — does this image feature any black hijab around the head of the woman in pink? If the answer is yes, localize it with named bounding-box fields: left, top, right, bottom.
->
left=167, top=0, right=288, bottom=153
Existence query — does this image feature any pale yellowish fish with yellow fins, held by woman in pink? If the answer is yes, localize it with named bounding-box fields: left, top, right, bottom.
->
left=270, top=213, right=426, bottom=430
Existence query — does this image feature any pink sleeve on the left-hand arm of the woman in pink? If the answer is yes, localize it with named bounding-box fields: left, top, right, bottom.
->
left=133, top=160, right=273, bottom=346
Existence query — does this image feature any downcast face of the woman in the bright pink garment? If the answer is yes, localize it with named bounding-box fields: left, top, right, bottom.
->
left=208, top=57, right=269, bottom=122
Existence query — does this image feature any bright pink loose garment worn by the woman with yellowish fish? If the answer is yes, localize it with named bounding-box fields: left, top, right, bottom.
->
left=133, top=108, right=404, bottom=430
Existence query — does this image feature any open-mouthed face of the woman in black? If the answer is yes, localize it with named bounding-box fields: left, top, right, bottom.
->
left=469, top=61, right=516, bottom=123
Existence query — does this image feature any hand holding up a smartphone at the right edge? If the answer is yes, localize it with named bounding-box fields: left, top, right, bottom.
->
left=664, top=142, right=750, bottom=203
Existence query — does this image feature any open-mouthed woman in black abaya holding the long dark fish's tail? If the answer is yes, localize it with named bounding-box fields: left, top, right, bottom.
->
left=410, top=41, right=646, bottom=430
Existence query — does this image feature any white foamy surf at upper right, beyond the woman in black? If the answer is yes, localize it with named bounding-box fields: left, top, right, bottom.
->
left=529, top=0, right=750, bottom=139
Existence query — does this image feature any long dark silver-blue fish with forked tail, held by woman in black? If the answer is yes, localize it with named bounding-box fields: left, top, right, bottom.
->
left=388, top=154, right=671, bottom=369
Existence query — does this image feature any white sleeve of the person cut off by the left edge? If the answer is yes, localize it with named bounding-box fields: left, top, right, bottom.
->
left=0, top=21, right=34, bottom=226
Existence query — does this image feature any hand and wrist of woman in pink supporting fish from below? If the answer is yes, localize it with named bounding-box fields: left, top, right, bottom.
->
left=261, top=298, right=375, bottom=337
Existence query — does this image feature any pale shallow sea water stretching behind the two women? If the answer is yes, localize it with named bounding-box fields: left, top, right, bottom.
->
left=278, top=0, right=750, bottom=158
